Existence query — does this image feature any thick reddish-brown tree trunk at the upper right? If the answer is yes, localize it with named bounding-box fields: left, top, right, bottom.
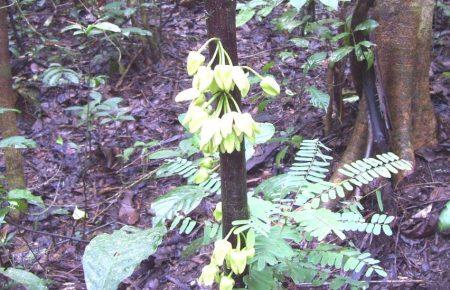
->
left=374, top=0, right=437, bottom=177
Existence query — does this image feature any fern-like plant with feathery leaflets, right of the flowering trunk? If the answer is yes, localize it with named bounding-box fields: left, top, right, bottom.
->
left=192, top=140, right=411, bottom=290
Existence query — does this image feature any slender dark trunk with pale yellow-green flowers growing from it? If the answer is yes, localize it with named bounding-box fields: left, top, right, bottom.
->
left=206, top=0, right=249, bottom=240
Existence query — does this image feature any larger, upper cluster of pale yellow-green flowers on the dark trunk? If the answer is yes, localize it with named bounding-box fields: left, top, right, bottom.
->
left=175, top=38, right=280, bottom=154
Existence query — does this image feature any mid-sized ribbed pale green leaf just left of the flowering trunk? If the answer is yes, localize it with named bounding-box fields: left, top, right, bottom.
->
left=151, top=185, right=208, bottom=225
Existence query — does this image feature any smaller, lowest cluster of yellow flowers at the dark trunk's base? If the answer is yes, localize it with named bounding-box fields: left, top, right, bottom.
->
left=198, top=230, right=255, bottom=290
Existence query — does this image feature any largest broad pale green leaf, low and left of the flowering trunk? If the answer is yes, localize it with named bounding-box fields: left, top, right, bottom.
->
left=82, top=226, right=166, bottom=290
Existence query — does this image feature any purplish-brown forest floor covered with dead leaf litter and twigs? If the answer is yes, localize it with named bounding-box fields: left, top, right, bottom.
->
left=0, top=5, right=450, bottom=289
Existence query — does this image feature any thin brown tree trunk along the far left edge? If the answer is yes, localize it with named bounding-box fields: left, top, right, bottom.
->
left=0, top=0, right=25, bottom=189
